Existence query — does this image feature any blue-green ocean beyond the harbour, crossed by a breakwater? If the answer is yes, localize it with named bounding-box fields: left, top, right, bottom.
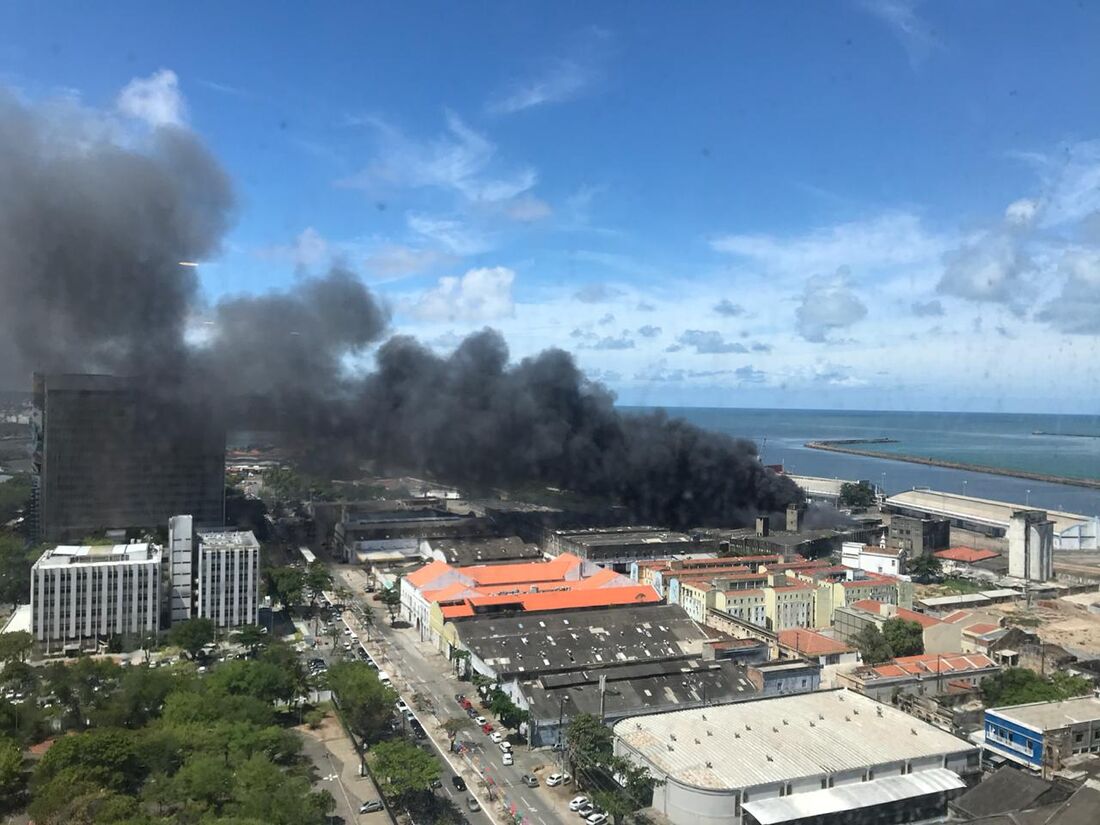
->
left=623, top=407, right=1100, bottom=515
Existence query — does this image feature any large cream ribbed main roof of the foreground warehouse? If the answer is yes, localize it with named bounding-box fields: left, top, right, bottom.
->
left=614, top=691, right=974, bottom=790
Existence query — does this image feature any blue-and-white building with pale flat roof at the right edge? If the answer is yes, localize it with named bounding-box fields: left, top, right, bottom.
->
left=982, top=696, right=1100, bottom=777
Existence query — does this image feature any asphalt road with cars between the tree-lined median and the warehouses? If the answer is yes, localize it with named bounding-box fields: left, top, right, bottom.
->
left=332, top=565, right=579, bottom=825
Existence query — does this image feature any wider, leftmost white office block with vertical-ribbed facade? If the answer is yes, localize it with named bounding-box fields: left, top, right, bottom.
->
left=31, top=543, right=161, bottom=649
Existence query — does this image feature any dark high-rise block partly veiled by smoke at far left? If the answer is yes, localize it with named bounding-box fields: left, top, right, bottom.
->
left=32, top=374, right=226, bottom=541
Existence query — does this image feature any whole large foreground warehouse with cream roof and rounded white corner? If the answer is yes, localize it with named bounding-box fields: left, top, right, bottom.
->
left=613, top=691, right=979, bottom=825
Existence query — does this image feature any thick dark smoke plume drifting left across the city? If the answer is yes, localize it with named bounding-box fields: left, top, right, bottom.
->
left=0, top=91, right=800, bottom=527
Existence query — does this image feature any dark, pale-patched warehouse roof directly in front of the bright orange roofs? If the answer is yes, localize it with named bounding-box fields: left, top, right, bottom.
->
left=455, top=604, right=710, bottom=673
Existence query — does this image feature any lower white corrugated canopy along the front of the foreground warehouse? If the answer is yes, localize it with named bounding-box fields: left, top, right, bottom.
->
left=744, top=768, right=966, bottom=825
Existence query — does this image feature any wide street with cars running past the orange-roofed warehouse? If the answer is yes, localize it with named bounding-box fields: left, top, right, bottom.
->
left=331, top=565, right=578, bottom=825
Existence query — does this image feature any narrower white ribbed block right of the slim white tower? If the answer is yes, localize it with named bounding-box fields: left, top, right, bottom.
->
left=194, top=530, right=260, bottom=627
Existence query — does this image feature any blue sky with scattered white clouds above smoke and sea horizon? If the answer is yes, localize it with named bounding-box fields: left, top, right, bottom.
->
left=0, top=0, right=1100, bottom=411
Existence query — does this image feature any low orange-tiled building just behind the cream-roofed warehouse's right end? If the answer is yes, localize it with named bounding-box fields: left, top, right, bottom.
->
left=837, top=653, right=1001, bottom=702
